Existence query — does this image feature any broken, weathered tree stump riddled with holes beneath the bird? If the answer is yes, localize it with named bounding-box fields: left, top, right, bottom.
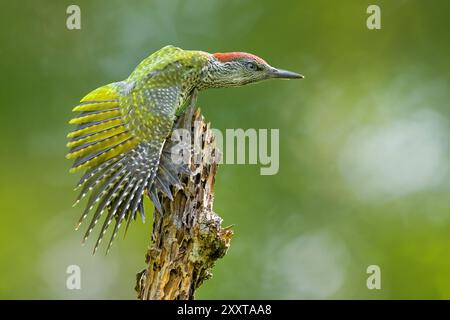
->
left=136, top=108, right=233, bottom=300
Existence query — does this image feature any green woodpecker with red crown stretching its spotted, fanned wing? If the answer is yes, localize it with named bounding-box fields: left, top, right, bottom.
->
left=67, top=46, right=303, bottom=253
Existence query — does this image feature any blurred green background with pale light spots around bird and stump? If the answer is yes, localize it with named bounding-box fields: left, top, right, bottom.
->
left=0, top=0, right=450, bottom=299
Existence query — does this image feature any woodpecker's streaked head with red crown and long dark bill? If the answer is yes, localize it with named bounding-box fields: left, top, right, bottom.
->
left=204, top=52, right=304, bottom=87
